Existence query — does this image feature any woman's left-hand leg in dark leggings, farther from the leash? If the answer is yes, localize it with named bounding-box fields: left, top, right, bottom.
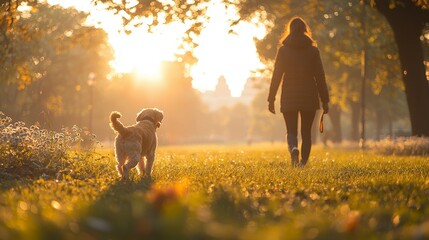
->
left=283, top=111, right=299, bottom=166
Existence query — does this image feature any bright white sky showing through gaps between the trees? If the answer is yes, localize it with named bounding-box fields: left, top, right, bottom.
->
left=48, top=0, right=267, bottom=97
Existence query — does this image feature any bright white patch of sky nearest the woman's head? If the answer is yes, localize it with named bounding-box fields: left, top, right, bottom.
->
left=190, top=2, right=266, bottom=97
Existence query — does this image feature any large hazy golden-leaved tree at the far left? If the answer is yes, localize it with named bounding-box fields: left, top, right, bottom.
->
left=0, top=1, right=111, bottom=128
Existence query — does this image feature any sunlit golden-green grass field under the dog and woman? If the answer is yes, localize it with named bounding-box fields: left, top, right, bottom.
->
left=0, top=145, right=429, bottom=239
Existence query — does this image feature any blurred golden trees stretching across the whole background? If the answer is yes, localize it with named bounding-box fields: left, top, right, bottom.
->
left=0, top=0, right=429, bottom=144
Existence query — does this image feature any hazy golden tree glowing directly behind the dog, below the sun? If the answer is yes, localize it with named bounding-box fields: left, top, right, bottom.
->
left=98, top=62, right=206, bottom=144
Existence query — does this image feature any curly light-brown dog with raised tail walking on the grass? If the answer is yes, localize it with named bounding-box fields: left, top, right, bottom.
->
left=110, top=108, right=164, bottom=180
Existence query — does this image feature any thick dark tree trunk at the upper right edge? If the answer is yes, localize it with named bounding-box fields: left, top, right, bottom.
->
left=377, top=1, right=429, bottom=136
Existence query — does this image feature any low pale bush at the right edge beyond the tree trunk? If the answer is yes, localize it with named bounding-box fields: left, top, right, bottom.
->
left=369, top=137, right=429, bottom=156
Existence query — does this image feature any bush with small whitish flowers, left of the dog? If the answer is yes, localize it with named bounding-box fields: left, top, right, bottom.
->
left=0, top=112, right=96, bottom=179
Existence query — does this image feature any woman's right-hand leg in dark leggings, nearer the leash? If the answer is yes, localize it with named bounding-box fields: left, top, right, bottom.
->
left=300, top=111, right=316, bottom=165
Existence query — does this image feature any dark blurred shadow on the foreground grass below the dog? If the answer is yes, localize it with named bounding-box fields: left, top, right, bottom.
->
left=77, top=176, right=202, bottom=239
